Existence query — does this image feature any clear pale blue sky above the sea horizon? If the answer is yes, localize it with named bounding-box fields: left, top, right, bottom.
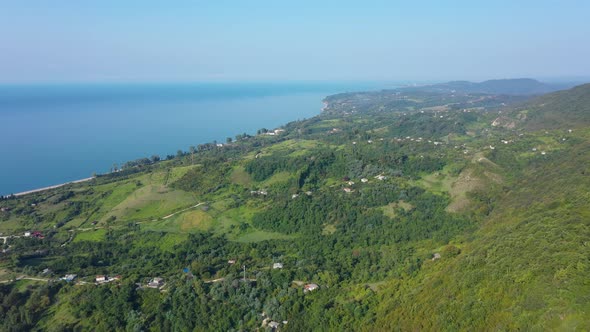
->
left=0, top=0, right=590, bottom=83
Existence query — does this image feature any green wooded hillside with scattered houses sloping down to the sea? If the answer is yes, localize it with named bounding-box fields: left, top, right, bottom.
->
left=0, top=80, right=590, bottom=331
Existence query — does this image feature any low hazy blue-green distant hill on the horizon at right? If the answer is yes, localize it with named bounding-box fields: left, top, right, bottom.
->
left=404, top=78, right=571, bottom=95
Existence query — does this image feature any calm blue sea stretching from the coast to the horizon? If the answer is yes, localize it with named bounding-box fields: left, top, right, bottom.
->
left=0, top=83, right=389, bottom=195
